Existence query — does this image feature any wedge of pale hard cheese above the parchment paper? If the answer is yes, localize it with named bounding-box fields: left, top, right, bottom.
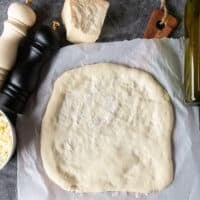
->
left=62, top=0, right=109, bottom=43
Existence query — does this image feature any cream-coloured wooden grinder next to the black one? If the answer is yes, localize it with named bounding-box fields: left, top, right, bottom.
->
left=0, top=2, right=36, bottom=88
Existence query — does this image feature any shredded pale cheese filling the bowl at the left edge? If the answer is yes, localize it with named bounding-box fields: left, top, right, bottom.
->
left=0, top=112, right=13, bottom=169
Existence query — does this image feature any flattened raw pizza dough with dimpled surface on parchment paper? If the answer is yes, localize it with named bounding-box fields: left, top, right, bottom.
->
left=41, top=63, right=174, bottom=193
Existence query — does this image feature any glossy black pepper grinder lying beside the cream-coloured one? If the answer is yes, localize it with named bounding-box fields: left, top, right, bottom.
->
left=0, top=26, right=59, bottom=124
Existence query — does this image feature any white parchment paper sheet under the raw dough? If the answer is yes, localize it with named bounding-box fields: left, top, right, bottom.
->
left=17, top=39, right=200, bottom=200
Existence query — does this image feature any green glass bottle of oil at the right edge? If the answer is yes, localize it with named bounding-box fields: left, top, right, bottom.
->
left=184, top=0, right=200, bottom=104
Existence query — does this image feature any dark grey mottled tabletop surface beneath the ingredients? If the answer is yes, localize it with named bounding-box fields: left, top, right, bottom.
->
left=0, top=0, right=185, bottom=200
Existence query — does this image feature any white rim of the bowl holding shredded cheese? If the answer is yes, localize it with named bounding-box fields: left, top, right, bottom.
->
left=0, top=111, right=17, bottom=170
